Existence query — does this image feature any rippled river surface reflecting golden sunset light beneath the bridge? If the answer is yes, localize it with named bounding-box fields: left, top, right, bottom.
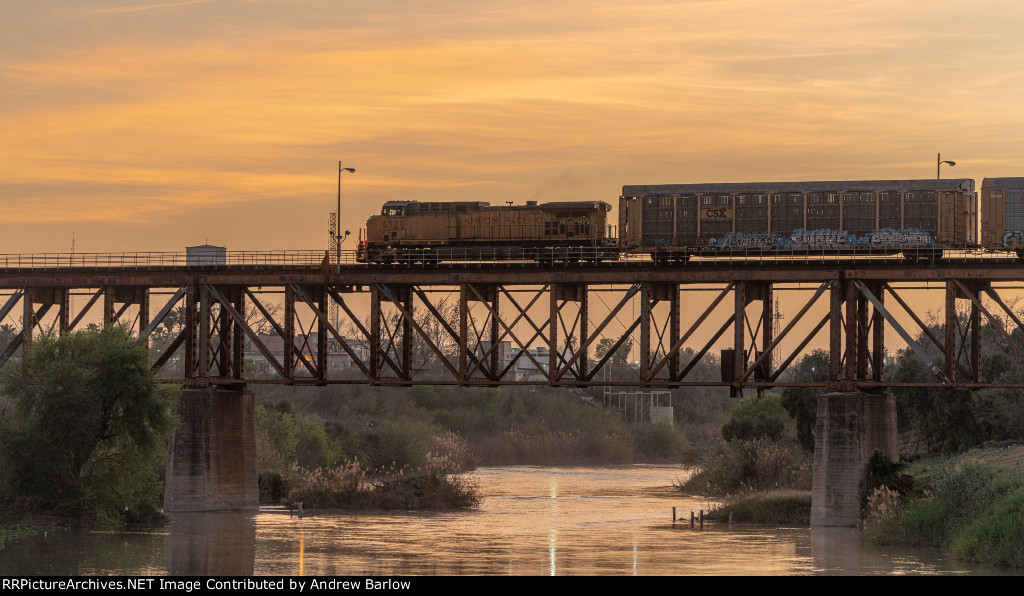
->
left=0, top=466, right=1002, bottom=576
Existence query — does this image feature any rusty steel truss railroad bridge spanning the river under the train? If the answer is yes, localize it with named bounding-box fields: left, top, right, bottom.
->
left=0, top=251, right=1024, bottom=391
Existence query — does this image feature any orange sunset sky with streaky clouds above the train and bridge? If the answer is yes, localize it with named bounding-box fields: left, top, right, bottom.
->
left=0, top=0, right=1024, bottom=253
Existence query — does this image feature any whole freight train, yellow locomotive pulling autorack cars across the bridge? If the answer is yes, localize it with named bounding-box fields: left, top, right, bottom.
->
left=357, top=177, right=1024, bottom=263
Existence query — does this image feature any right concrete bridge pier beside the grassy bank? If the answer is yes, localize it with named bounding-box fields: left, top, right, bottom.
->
left=811, top=391, right=899, bottom=526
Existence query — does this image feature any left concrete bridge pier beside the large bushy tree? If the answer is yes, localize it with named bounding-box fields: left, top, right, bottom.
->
left=164, top=387, right=259, bottom=512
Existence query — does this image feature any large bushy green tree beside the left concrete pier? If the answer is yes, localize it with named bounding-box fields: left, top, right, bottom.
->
left=0, top=326, right=176, bottom=522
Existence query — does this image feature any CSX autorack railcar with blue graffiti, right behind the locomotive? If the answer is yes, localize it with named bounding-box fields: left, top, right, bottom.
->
left=618, top=178, right=974, bottom=262
